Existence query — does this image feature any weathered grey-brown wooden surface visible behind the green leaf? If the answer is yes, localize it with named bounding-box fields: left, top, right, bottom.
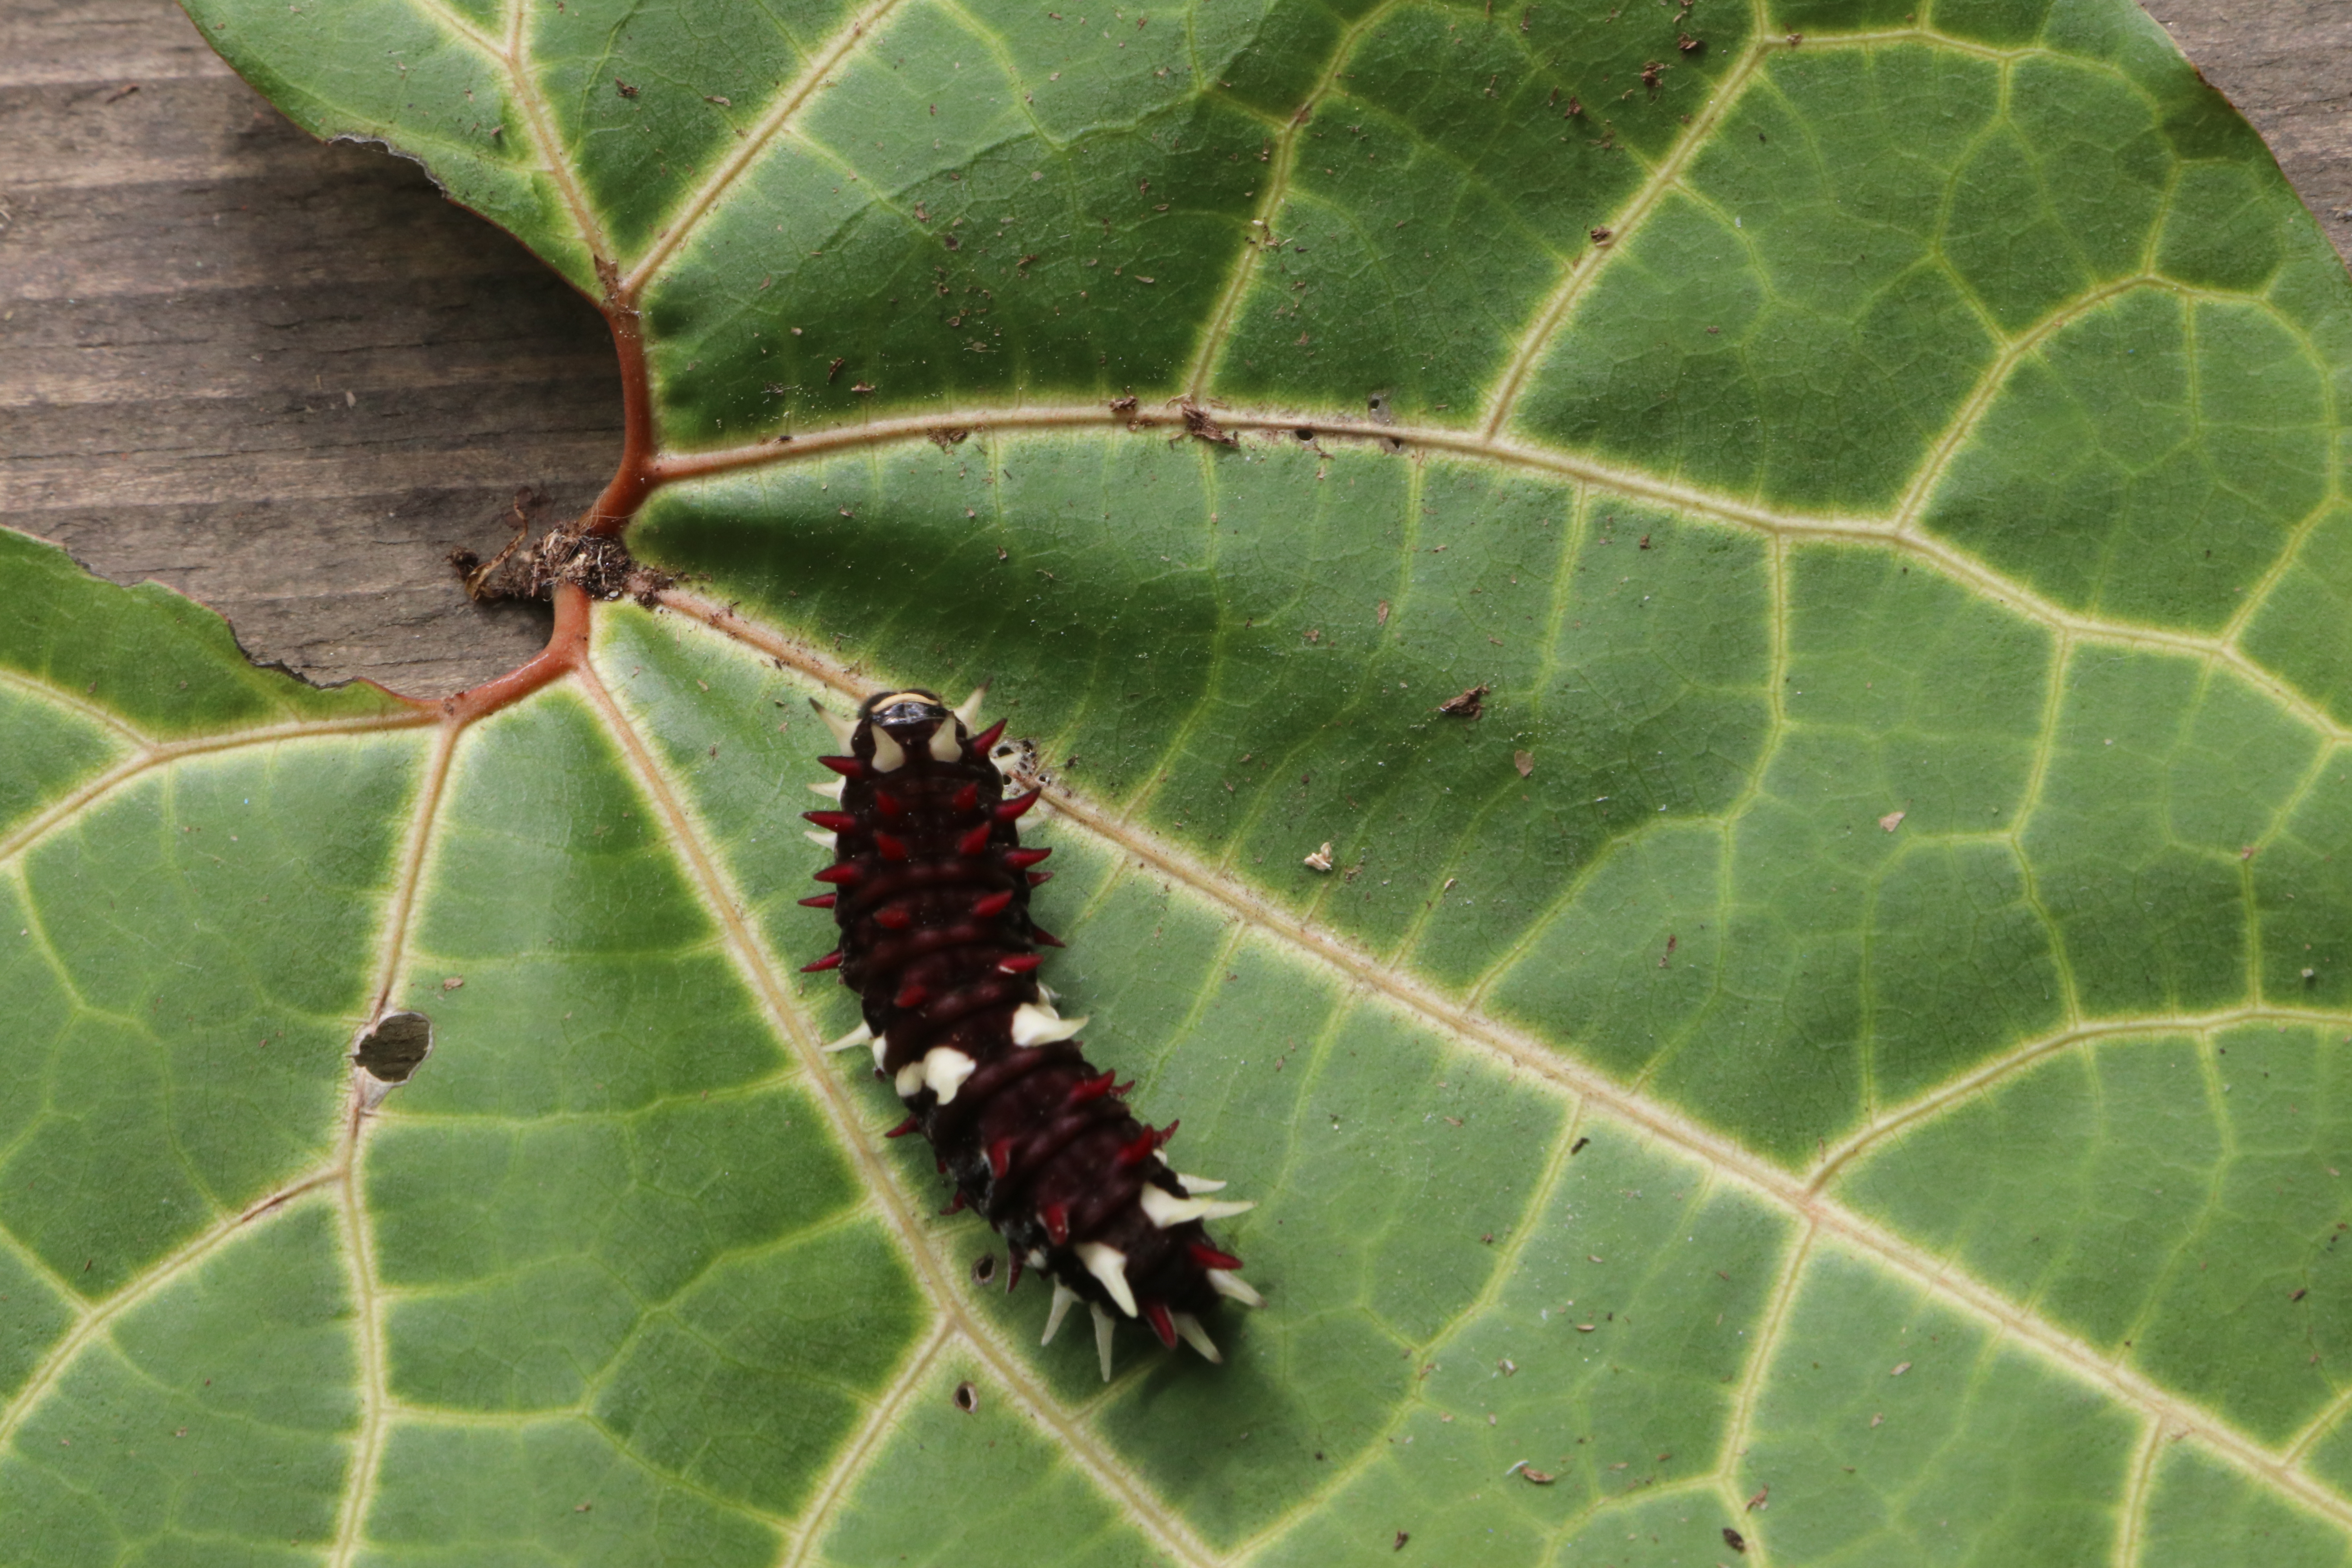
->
left=0, top=0, right=2352, bottom=696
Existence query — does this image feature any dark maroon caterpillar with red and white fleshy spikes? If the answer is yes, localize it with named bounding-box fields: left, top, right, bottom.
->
left=800, top=686, right=1261, bottom=1382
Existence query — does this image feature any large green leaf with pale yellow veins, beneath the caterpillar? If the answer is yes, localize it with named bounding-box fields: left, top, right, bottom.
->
left=14, top=0, right=2352, bottom=1568
